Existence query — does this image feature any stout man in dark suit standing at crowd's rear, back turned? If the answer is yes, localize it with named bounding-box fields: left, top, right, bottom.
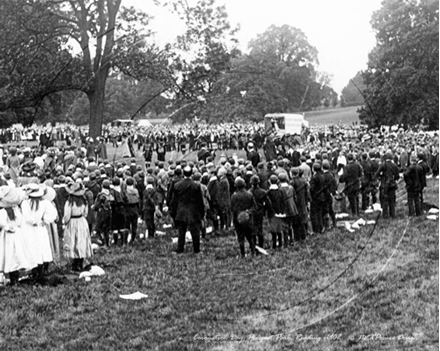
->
left=169, top=167, right=205, bottom=254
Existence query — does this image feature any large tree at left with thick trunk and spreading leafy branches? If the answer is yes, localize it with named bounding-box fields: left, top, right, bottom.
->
left=0, top=0, right=153, bottom=136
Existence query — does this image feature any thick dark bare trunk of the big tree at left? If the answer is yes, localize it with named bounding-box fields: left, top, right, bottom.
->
left=87, top=69, right=108, bottom=140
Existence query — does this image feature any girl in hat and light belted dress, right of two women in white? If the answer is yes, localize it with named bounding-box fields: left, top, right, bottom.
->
left=63, top=183, right=93, bottom=272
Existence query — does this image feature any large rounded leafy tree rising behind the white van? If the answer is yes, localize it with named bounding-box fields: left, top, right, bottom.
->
left=205, top=25, right=337, bottom=121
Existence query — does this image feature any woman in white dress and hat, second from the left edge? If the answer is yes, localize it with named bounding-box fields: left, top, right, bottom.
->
left=21, top=184, right=58, bottom=280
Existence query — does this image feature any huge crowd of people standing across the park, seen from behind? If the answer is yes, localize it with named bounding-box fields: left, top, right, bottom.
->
left=0, top=121, right=439, bottom=285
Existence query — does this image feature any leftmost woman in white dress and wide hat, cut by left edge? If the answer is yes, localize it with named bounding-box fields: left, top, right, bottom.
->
left=0, top=186, right=34, bottom=286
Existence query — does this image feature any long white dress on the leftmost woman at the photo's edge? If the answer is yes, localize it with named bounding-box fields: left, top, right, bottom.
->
left=0, top=207, right=35, bottom=273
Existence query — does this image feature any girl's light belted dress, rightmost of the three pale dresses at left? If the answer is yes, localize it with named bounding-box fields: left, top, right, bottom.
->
left=63, top=201, right=93, bottom=258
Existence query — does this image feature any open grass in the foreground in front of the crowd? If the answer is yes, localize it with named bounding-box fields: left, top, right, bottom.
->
left=0, top=174, right=439, bottom=351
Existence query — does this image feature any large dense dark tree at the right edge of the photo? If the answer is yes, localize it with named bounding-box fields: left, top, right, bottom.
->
left=360, top=0, right=439, bottom=129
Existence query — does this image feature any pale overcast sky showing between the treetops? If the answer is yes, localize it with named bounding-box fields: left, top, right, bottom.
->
left=122, top=0, right=382, bottom=93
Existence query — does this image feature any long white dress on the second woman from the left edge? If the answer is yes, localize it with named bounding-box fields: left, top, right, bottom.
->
left=21, top=200, right=57, bottom=267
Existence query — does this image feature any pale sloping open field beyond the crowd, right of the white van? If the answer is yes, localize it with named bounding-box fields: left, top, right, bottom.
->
left=304, top=106, right=361, bottom=127
